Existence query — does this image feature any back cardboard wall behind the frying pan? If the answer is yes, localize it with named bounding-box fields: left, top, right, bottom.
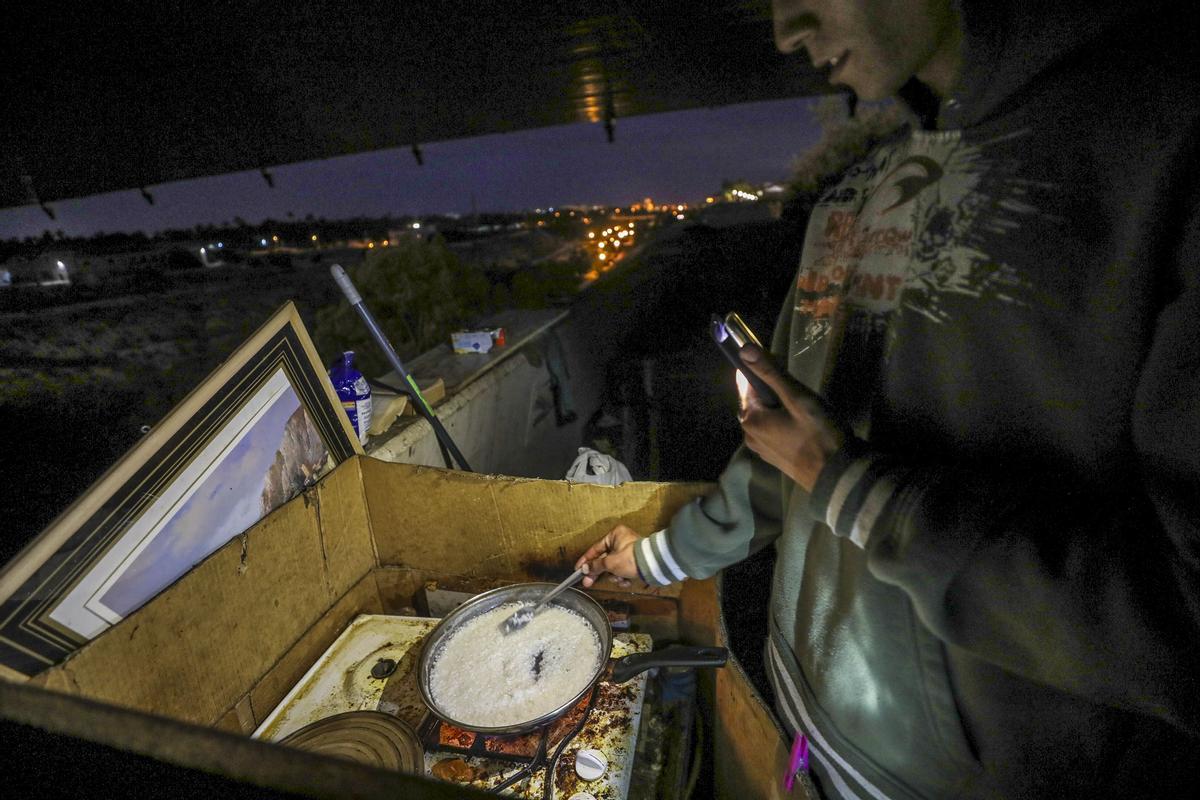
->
left=361, top=458, right=708, bottom=594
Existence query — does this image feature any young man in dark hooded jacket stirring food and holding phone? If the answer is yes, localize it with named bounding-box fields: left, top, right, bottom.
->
left=580, top=0, right=1200, bottom=800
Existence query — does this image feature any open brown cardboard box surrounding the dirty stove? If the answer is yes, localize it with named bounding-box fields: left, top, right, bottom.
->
left=0, top=456, right=796, bottom=798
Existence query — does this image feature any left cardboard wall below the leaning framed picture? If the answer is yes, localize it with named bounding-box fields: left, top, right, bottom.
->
left=34, top=459, right=374, bottom=724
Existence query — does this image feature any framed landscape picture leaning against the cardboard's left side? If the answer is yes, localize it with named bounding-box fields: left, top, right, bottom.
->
left=0, top=303, right=362, bottom=675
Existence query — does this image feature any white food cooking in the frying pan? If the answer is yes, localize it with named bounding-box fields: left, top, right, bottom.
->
left=430, top=603, right=600, bottom=728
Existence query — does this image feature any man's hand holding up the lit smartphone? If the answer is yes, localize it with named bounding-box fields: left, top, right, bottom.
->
left=738, top=344, right=846, bottom=492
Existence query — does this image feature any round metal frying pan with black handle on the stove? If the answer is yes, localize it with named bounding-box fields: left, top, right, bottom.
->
left=416, top=583, right=728, bottom=734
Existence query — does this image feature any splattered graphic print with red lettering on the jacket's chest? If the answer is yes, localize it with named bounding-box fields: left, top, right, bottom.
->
left=788, top=132, right=1049, bottom=435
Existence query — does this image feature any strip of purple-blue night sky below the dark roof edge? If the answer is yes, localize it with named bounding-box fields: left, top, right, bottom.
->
left=0, top=98, right=818, bottom=239
